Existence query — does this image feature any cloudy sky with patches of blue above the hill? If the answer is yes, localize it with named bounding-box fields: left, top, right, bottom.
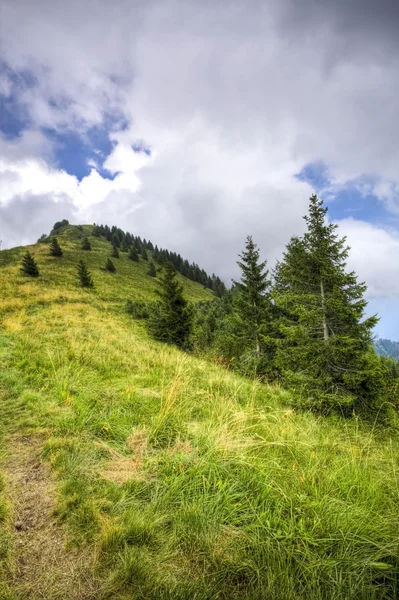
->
left=0, top=0, right=399, bottom=340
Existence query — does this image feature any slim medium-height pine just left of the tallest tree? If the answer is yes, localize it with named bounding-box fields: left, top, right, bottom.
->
left=232, top=236, right=273, bottom=373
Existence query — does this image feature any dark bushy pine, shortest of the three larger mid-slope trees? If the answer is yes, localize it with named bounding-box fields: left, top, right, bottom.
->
left=148, top=262, right=191, bottom=348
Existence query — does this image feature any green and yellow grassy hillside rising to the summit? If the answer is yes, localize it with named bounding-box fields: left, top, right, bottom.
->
left=0, top=228, right=399, bottom=600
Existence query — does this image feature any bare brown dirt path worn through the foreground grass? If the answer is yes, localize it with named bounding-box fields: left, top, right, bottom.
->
left=3, top=436, right=100, bottom=600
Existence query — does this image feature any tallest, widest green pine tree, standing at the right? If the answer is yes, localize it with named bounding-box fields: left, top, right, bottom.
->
left=274, top=195, right=379, bottom=411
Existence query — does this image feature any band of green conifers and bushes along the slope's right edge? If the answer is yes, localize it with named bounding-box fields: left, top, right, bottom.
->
left=137, top=195, right=399, bottom=419
